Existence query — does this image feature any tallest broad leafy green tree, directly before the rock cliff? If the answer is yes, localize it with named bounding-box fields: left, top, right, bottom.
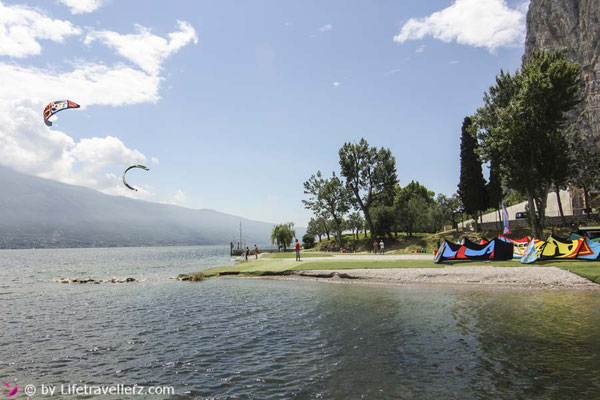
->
left=476, top=50, right=580, bottom=237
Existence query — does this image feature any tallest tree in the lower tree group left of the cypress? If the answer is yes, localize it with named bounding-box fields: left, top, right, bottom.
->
left=339, top=138, right=398, bottom=234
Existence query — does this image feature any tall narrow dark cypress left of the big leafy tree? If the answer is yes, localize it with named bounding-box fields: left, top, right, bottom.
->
left=458, top=117, right=487, bottom=231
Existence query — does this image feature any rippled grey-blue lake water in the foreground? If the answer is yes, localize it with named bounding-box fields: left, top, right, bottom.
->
left=0, top=247, right=600, bottom=399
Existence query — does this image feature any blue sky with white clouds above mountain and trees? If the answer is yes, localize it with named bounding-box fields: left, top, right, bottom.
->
left=0, top=0, right=528, bottom=226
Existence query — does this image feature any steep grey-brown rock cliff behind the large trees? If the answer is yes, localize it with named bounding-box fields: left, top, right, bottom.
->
left=524, top=0, right=600, bottom=137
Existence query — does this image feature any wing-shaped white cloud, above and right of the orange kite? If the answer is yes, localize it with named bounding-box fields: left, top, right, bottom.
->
left=84, top=21, right=198, bottom=75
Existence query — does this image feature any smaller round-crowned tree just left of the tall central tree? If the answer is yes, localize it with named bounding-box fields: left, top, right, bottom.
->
left=302, top=171, right=350, bottom=246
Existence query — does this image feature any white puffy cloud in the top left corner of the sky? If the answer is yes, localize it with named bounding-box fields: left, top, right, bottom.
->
left=0, top=1, right=81, bottom=58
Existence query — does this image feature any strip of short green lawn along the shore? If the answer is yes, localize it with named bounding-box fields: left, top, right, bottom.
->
left=184, top=254, right=600, bottom=284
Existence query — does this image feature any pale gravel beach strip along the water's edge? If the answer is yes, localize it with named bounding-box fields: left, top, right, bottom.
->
left=254, top=266, right=600, bottom=290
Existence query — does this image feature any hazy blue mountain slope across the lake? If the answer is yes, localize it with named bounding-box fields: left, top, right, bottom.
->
left=0, top=167, right=303, bottom=248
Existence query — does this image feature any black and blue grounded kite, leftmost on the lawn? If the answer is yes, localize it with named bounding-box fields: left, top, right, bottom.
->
left=434, top=238, right=513, bottom=264
